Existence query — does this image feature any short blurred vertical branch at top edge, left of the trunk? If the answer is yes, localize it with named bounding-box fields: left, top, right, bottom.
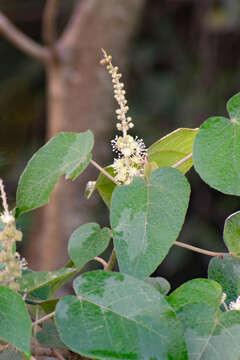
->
left=42, top=0, right=58, bottom=47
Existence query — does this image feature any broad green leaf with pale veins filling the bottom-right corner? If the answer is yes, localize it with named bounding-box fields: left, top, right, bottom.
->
left=178, top=303, right=240, bottom=360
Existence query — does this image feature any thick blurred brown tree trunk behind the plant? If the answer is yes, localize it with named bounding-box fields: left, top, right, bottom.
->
left=26, top=0, right=145, bottom=270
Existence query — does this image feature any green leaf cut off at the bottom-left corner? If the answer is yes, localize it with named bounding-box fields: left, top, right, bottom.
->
left=0, top=286, right=32, bottom=356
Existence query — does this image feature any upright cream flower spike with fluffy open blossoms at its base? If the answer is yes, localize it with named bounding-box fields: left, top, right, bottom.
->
left=101, top=50, right=146, bottom=185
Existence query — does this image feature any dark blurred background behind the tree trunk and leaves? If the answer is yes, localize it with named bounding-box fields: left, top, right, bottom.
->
left=0, top=0, right=240, bottom=287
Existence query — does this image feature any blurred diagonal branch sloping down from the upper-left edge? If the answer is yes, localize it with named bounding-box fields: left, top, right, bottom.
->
left=0, top=11, right=50, bottom=62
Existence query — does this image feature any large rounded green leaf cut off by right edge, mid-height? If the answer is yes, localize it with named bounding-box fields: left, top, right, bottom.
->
left=193, top=94, right=240, bottom=195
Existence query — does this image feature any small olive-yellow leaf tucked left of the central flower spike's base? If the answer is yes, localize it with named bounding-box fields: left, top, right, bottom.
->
left=95, top=166, right=116, bottom=208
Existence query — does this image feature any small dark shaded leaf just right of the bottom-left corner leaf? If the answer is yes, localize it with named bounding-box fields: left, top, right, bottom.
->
left=36, top=321, right=66, bottom=348
